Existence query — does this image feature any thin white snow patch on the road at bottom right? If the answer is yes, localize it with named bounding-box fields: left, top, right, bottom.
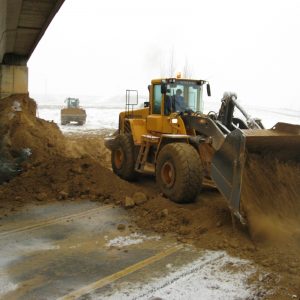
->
left=101, top=251, right=262, bottom=300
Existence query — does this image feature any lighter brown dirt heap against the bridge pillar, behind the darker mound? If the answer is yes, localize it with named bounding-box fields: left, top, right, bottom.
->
left=0, top=94, right=108, bottom=173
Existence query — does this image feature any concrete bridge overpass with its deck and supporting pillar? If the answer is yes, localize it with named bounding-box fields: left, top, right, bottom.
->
left=0, top=0, right=64, bottom=98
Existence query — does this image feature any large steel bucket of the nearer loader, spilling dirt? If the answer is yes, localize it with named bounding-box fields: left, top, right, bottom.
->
left=211, top=123, right=300, bottom=223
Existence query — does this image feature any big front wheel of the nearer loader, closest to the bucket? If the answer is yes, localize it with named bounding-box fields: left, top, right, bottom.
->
left=156, top=143, right=203, bottom=203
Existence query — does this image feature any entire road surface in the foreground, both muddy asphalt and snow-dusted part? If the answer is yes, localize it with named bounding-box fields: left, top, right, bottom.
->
left=0, top=201, right=253, bottom=300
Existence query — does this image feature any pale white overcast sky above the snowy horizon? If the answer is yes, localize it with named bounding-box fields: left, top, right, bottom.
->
left=28, top=0, right=300, bottom=110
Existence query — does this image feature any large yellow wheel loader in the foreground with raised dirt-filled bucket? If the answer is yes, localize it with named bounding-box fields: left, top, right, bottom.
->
left=105, top=78, right=300, bottom=222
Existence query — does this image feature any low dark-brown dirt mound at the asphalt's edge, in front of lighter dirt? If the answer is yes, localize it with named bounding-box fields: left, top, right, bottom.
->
left=0, top=157, right=138, bottom=209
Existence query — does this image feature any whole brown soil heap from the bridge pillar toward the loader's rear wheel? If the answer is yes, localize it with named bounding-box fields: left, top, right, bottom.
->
left=0, top=95, right=145, bottom=212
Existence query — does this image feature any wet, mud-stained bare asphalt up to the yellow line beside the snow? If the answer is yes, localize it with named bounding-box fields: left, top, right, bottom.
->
left=0, top=202, right=189, bottom=299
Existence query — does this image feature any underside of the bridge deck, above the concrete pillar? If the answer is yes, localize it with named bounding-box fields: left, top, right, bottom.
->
left=0, top=0, right=64, bottom=65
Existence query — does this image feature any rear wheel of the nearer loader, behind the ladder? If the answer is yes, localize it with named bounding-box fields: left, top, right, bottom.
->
left=111, top=134, right=136, bottom=181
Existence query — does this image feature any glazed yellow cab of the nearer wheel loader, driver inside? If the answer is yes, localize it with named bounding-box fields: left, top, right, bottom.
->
left=147, top=78, right=206, bottom=134
